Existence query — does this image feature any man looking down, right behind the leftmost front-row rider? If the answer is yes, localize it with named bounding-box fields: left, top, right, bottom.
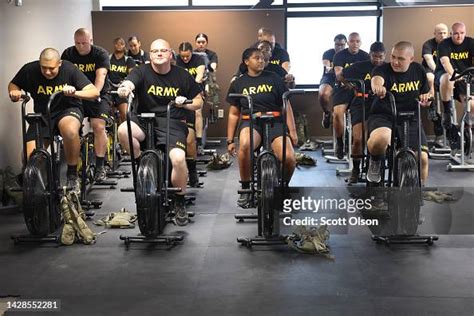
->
left=61, top=28, right=110, bottom=182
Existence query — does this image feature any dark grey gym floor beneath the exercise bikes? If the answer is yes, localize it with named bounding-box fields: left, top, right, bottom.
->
left=0, top=142, right=474, bottom=316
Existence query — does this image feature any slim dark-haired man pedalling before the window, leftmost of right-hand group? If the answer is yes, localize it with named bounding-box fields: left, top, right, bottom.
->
left=318, top=34, right=347, bottom=128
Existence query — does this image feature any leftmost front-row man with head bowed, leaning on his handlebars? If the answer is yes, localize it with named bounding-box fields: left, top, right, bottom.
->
left=8, top=48, right=99, bottom=191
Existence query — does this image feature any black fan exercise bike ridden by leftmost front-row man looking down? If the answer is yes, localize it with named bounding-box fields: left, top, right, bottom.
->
left=11, top=91, right=62, bottom=244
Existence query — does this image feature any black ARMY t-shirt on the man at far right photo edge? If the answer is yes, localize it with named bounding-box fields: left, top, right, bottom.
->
left=436, top=36, right=474, bottom=73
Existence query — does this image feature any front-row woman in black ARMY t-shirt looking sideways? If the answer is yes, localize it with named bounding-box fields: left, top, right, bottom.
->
left=227, top=48, right=298, bottom=207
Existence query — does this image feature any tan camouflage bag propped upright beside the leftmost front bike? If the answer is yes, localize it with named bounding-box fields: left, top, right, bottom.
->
left=61, top=190, right=96, bottom=245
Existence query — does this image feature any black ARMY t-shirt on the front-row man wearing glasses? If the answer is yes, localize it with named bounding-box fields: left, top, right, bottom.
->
left=125, top=64, right=201, bottom=120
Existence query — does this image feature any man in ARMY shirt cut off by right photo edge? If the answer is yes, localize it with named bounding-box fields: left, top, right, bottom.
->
left=435, top=22, right=474, bottom=134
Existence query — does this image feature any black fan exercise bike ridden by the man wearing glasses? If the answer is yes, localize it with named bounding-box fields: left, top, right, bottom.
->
left=116, top=92, right=194, bottom=246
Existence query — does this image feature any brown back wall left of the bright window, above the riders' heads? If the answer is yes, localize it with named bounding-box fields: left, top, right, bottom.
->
left=92, top=10, right=285, bottom=137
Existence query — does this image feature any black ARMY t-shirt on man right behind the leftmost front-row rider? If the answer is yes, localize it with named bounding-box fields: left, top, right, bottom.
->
left=61, top=45, right=110, bottom=94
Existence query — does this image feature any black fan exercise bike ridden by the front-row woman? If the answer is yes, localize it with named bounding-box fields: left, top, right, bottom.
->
left=229, top=90, right=305, bottom=248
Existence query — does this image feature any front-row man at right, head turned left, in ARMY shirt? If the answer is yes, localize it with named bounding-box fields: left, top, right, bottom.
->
left=367, top=42, right=431, bottom=183
